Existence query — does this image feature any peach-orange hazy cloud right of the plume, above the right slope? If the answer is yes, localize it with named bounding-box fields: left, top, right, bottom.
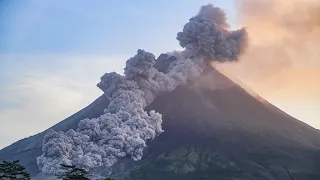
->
left=215, top=0, right=320, bottom=128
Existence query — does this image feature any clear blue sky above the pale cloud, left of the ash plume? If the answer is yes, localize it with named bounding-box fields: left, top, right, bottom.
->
left=0, top=0, right=234, bottom=55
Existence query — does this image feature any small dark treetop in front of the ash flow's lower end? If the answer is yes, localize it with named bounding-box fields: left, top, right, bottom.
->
left=58, top=164, right=90, bottom=180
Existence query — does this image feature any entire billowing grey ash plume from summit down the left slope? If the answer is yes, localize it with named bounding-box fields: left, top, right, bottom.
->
left=37, top=5, right=246, bottom=174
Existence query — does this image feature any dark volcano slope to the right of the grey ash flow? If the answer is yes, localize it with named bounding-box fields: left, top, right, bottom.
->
left=120, top=69, right=320, bottom=179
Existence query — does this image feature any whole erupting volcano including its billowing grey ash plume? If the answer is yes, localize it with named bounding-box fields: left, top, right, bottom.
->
left=0, top=4, right=320, bottom=180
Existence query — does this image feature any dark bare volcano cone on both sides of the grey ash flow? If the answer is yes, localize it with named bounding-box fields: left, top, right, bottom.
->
left=0, top=65, right=320, bottom=180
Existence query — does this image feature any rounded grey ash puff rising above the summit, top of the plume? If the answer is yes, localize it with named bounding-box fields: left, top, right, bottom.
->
left=177, top=5, right=247, bottom=62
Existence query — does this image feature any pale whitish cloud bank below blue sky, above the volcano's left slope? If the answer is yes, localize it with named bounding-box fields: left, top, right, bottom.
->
left=0, top=54, right=129, bottom=149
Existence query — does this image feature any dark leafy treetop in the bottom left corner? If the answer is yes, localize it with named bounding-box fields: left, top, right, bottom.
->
left=0, top=160, right=30, bottom=180
